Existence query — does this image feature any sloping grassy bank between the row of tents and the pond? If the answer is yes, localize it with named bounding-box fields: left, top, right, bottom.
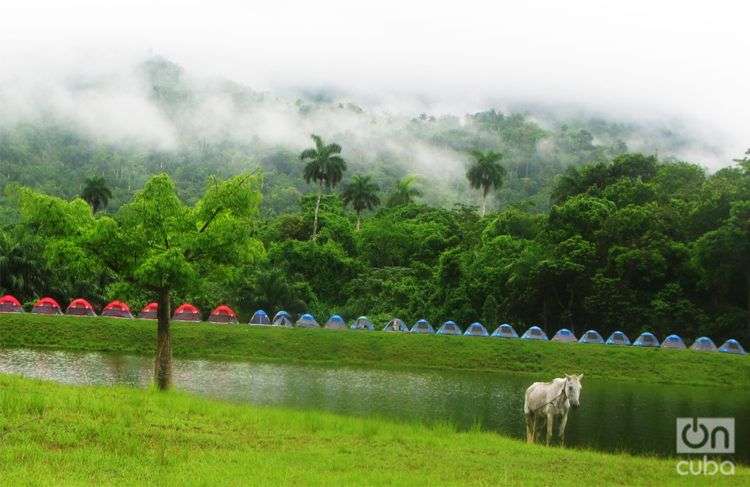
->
left=0, top=314, right=750, bottom=387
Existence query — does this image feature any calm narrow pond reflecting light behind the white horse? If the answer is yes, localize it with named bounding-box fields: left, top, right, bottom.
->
left=0, top=350, right=750, bottom=463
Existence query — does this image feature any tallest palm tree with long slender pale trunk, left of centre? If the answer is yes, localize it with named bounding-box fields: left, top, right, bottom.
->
left=299, top=134, right=346, bottom=240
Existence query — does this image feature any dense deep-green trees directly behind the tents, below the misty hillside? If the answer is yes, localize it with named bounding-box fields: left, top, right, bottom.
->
left=0, top=154, right=750, bottom=343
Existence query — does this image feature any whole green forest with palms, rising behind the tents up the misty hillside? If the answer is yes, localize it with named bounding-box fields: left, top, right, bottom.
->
left=0, top=59, right=750, bottom=343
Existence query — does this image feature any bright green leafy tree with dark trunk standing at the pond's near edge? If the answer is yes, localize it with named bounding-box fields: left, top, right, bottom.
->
left=86, top=174, right=262, bottom=389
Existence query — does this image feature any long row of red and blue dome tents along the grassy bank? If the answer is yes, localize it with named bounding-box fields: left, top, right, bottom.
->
left=0, top=295, right=746, bottom=355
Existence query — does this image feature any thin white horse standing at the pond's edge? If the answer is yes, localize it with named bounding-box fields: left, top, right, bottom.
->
left=523, top=374, right=583, bottom=445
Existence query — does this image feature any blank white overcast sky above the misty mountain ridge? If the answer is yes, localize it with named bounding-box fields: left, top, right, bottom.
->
left=0, top=0, right=750, bottom=164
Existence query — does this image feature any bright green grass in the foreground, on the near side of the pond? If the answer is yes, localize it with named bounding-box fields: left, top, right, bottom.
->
left=0, top=375, right=750, bottom=485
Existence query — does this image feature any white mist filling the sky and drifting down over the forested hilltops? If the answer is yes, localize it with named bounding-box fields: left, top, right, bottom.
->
left=0, top=0, right=750, bottom=173
